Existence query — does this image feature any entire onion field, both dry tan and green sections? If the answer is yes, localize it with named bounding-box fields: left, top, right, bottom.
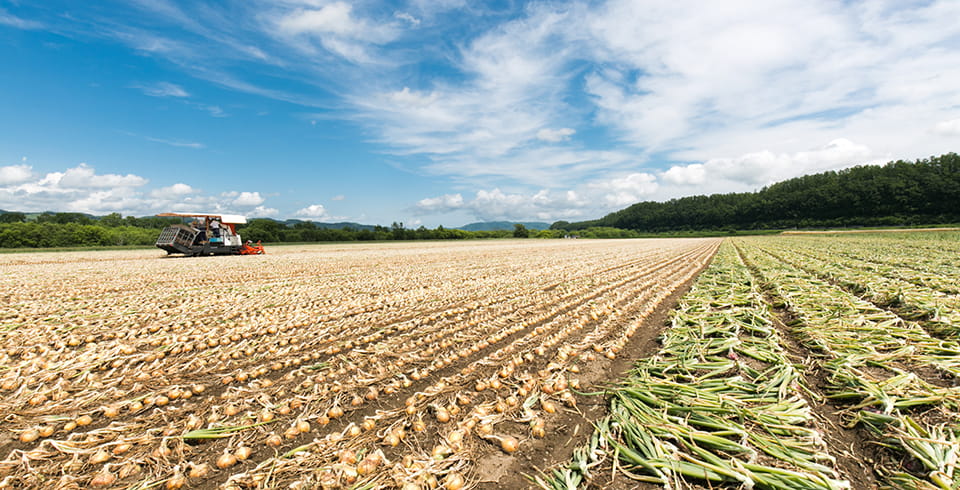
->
left=0, top=231, right=960, bottom=490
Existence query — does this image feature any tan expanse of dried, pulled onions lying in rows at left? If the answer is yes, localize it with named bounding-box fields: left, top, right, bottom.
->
left=0, top=241, right=715, bottom=488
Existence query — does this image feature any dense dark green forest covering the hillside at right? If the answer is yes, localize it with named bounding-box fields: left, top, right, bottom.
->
left=550, top=153, right=960, bottom=232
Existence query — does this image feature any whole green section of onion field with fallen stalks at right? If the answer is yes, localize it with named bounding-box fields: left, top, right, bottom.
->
left=539, top=232, right=960, bottom=489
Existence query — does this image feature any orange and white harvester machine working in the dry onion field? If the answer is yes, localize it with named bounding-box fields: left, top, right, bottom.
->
left=157, top=213, right=264, bottom=257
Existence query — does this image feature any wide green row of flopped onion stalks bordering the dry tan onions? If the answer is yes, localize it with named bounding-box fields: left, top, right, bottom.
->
left=536, top=244, right=850, bottom=489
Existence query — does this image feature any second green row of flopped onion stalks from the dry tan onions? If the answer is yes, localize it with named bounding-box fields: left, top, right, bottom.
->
left=739, top=240, right=960, bottom=489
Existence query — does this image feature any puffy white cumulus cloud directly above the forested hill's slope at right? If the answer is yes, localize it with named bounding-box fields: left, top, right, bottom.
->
left=660, top=139, right=878, bottom=190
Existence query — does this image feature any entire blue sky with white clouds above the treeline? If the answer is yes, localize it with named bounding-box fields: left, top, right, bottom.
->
left=0, top=0, right=960, bottom=227
